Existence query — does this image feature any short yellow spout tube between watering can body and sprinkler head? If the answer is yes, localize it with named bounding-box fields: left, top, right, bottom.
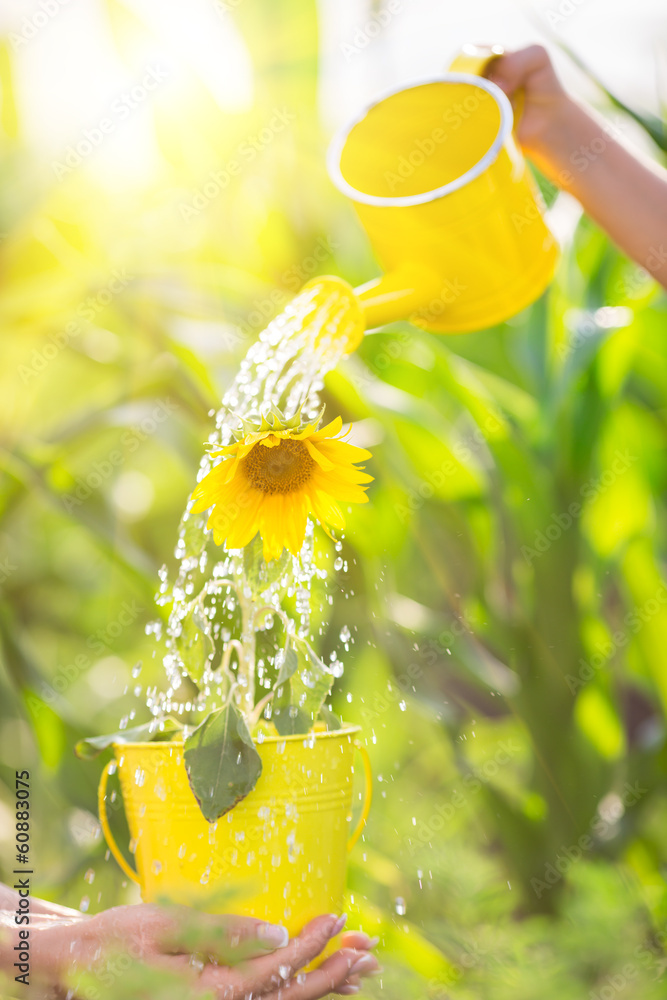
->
left=354, top=264, right=442, bottom=330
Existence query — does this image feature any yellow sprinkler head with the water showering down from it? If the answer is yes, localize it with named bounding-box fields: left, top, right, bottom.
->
left=150, top=278, right=363, bottom=724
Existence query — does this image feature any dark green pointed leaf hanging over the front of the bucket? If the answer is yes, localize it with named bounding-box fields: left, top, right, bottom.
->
left=185, top=704, right=262, bottom=823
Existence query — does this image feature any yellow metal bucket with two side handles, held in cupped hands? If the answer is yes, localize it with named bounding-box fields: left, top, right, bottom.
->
left=99, top=727, right=372, bottom=935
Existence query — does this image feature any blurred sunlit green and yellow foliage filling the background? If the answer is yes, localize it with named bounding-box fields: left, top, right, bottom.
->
left=0, top=0, right=667, bottom=1000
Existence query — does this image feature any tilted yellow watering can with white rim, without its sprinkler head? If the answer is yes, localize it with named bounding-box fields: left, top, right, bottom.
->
left=328, top=46, right=558, bottom=350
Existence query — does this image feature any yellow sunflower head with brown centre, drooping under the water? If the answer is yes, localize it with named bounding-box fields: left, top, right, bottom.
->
left=192, top=408, right=373, bottom=562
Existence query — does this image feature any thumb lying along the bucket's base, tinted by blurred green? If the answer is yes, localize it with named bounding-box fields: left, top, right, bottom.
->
left=153, top=907, right=289, bottom=965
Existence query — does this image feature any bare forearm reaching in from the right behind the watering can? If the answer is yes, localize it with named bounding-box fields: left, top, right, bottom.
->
left=527, top=97, right=667, bottom=287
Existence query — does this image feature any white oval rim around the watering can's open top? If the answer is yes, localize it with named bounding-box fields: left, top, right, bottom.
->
left=327, top=73, right=514, bottom=208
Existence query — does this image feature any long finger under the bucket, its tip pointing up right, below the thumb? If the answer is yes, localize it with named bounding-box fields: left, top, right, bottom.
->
left=201, top=914, right=344, bottom=1000
